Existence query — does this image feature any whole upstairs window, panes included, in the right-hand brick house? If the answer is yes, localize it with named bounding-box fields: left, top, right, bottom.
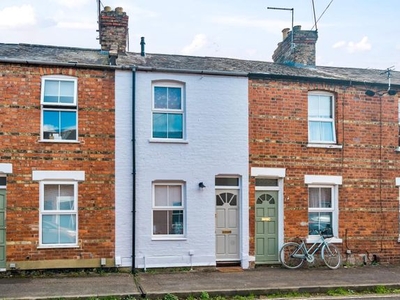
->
left=308, top=92, right=336, bottom=143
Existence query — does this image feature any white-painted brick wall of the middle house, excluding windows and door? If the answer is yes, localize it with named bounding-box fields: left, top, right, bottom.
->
left=116, top=71, right=249, bottom=268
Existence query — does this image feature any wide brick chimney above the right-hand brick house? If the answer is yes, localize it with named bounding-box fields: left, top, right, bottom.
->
left=272, top=26, right=318, bottom=67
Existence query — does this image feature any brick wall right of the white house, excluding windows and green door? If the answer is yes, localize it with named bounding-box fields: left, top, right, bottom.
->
left=249, top=79, right=400, bottom=263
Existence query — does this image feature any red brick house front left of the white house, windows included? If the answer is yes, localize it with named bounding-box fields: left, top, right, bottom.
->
left=0, top=57, right=115, bottom=269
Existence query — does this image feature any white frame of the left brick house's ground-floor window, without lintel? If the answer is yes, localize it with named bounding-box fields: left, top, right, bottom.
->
left=39, top=180, right=79, bottom=248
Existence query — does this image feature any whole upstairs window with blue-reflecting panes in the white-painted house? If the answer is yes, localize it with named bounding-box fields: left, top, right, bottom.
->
left=152, top=84, right=184, bottom=139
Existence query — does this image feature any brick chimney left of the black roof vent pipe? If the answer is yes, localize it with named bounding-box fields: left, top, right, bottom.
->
left=99, top=6, right=129, bottom=56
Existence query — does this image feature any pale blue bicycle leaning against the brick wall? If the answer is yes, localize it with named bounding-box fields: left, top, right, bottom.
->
left=279, top=234, right=342, bottom=269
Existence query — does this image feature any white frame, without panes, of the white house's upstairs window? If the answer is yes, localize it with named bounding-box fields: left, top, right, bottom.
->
left=150, top=81, right=186, bottom=142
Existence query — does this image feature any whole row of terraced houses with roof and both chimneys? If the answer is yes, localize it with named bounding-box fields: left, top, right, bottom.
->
left=0, top=3, right=400, bottom=270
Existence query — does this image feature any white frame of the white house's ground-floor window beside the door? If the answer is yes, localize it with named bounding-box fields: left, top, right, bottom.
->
left=151, top=181, right=187, bottom=240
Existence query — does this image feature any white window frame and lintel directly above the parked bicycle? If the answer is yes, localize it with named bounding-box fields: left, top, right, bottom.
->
left=304, top=175, right=342, bottom=243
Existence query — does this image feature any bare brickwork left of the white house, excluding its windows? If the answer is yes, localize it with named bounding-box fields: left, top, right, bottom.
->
left=0, top=64, right=115, bottom=268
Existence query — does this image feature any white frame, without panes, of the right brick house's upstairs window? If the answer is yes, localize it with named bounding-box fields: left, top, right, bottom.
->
left=307, top=91, right=336, bottom=145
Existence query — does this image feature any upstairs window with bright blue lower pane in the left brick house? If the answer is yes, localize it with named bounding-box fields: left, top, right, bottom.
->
left=41, top=77, right=78, bottom=141
